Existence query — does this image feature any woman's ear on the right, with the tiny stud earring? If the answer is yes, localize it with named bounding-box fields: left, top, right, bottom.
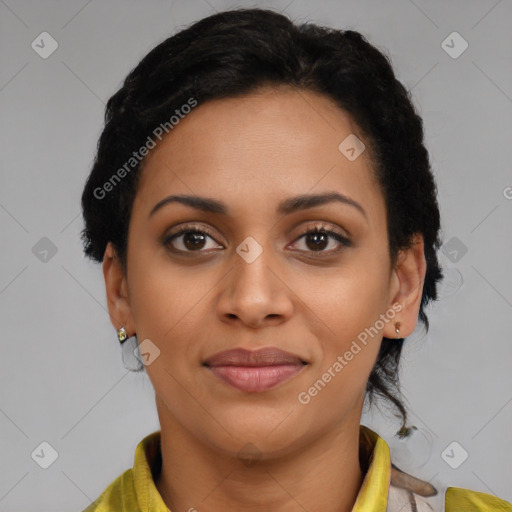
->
left=383, top=234, right=427, bottom=339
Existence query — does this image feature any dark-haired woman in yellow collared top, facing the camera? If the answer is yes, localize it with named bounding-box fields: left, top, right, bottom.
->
left=82, top=9, right=510, bottom=512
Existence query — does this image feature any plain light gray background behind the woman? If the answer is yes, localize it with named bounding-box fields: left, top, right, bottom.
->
left=0, top=0, right=512, bottom=512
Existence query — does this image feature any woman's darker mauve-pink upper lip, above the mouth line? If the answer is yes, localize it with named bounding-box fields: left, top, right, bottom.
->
left=204, top=347, right=306, bottom=366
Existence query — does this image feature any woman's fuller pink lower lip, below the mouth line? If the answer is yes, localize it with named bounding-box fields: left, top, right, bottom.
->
left=209, top=364, right=306, bottom=392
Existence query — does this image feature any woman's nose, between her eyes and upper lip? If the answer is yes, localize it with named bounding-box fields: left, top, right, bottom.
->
left=217, top=242, right=294, bottom=329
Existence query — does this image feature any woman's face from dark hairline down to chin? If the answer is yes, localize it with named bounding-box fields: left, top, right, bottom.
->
left=106, top=88, right=424, bottom=457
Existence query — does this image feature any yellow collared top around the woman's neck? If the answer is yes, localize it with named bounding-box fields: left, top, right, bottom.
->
left=83, top=425, right=512, bottom=512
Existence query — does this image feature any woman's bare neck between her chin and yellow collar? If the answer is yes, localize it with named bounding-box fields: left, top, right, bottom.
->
left=155, top=401, right=365, bottom=512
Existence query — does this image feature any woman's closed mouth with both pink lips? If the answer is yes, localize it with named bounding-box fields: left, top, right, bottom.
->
left=203, top=348, right=308, bottom=393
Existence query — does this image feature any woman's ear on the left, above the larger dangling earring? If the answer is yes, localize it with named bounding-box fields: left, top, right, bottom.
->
left=103, top=242, right=135, bottom=337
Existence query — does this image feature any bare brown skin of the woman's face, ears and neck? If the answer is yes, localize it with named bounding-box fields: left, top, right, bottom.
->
left=103, top=87, right=426, bottom=512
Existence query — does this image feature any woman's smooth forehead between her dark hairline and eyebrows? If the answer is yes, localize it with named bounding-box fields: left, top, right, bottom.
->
left=136, top=88, right=383, bottom=222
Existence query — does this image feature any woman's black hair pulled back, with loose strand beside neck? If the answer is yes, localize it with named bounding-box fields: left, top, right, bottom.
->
left=82, top=9, right=443, bottom=427
